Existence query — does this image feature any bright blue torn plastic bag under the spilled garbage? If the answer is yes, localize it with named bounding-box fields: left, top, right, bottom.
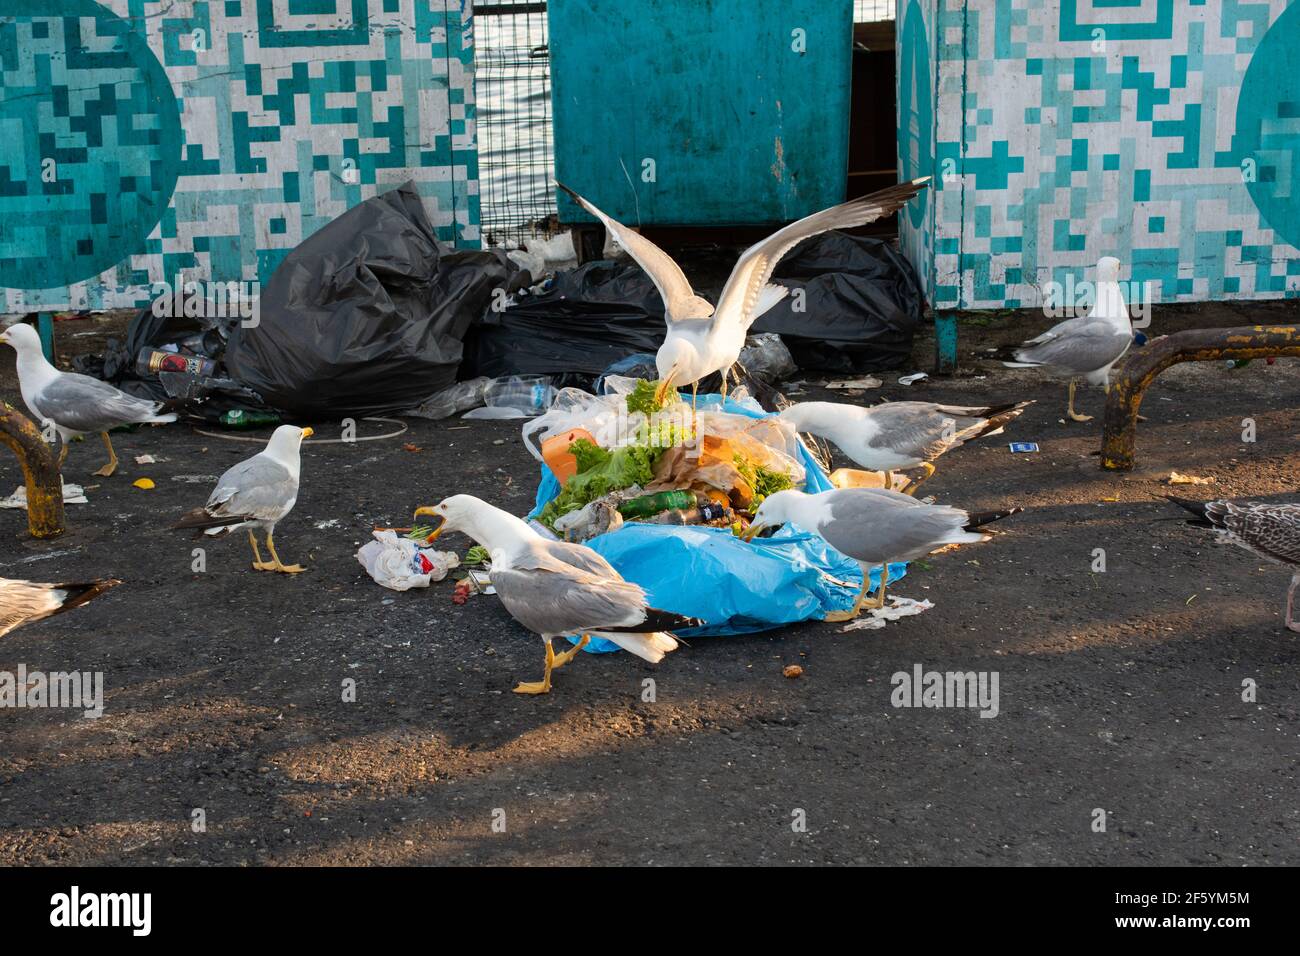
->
left=529, top=395, right=907, bottom=653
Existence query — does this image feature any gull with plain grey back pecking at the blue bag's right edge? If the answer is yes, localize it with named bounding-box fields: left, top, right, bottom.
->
left=745, top=488, right=1021, bottom=620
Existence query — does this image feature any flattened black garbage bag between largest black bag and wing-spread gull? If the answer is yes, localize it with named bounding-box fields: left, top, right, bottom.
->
left=460, top=261, right=664, bottom=388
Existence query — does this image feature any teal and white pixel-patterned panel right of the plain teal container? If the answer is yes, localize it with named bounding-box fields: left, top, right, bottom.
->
left=897, top=0, right=1300, bottom=308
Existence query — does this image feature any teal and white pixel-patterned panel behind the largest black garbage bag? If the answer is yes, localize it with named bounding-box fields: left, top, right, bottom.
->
left=0, top=0, right=478, bottom=312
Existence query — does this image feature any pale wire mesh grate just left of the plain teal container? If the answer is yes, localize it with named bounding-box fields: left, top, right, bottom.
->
left=475, top=0, right=555, bottom=248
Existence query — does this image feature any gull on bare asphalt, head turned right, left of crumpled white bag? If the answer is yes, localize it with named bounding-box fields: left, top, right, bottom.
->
left=172, top=425, right=312, bottom=574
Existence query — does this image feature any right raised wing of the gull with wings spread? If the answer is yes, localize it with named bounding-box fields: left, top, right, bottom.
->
left=716, top=177, right=930, bottom=329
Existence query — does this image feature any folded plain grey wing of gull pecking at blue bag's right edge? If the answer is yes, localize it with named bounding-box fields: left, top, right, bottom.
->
left=818, top=489, right=974, bottom=564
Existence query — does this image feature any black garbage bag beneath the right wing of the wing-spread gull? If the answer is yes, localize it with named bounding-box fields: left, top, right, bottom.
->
left=750, top=232, right=926, bottom=372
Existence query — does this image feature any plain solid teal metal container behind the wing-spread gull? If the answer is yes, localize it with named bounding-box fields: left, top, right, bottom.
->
left=549, top=0, right=853, bottom=225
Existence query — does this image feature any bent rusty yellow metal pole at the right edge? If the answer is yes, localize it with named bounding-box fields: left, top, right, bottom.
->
left=1101, top=325, right=1300, bottom=471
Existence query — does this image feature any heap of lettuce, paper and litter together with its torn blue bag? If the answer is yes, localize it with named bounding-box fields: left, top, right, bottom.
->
left=524, top=376, right=906, bottom=639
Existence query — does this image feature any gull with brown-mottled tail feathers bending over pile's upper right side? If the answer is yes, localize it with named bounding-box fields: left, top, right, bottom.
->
left=779, top=402, right=1034, bottom=494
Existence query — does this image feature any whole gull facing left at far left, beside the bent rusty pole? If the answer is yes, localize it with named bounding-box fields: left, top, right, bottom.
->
left=0, top=323, right=176, bottom=477
